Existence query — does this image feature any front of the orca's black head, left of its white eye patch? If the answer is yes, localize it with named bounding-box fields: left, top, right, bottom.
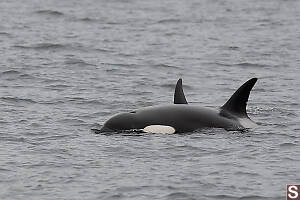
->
left=100, top=112, right=137, bottom=132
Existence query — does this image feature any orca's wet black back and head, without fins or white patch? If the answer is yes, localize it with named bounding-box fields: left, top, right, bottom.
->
left=100, top=104, right=242, bottom=133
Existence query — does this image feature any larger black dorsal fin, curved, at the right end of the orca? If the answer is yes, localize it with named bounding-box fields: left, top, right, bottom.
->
left=221, top=78, right=257, bottom=117
